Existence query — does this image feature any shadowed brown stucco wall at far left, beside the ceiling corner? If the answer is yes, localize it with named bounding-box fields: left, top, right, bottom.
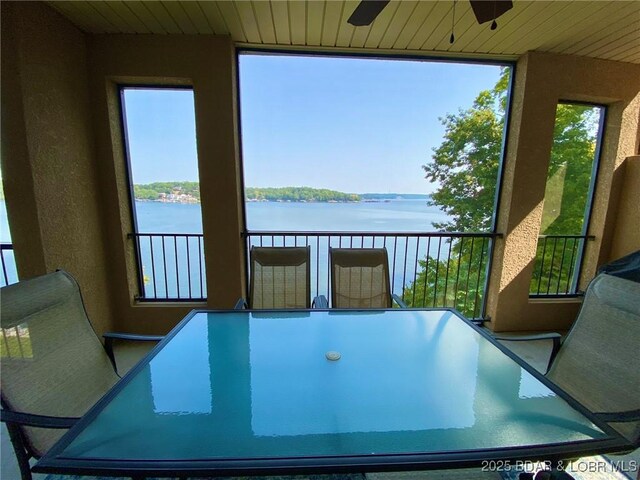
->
left=2, top=2, right=113, bottom=333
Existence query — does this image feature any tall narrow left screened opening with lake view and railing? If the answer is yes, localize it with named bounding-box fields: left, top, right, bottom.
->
left=121, top=87, right=207, bottom=301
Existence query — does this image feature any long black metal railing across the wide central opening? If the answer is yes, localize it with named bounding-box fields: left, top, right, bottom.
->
left=244, top=231, right=499, bottom=318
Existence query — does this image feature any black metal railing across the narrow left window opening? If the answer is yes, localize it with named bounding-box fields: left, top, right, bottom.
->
left=129, top=233, right=207, bottom=302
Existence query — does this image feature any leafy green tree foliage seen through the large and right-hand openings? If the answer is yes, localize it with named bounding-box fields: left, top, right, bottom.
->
left=404, top=68, right=599, bottom=316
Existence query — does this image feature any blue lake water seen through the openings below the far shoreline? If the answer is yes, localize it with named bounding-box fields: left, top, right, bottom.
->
left=0, top=200, right=460, bottom=298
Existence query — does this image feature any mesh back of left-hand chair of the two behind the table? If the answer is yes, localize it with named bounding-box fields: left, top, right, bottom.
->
left=249, top=247, right=311, bottom=309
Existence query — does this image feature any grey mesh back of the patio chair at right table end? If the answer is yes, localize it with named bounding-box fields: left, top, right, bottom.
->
left=547, top=274, right=640, bottom=443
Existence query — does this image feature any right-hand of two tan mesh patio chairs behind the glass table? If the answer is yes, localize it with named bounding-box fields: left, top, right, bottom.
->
left=329, top=248, right=406, bottom=308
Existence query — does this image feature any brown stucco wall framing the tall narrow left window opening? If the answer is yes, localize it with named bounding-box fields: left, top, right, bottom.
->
left=89, top=35, right=244, bottom=333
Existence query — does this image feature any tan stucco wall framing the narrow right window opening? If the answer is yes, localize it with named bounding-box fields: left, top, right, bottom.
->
left=487, top=52, right=640, bottom=331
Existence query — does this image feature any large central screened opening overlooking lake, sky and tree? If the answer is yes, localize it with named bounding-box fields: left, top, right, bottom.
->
left=238, top=51, right=512, bottom=318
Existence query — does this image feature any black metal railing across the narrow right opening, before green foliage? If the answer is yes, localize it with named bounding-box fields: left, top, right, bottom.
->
left=529, top=235, right=594, bottom=297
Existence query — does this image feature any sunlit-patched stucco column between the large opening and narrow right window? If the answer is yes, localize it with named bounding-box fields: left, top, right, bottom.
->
left=487, top=55, right=556, bottom=331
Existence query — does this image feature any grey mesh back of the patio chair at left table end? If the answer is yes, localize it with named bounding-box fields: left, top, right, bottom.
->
left=0, top=271, right=118, bottom=456
